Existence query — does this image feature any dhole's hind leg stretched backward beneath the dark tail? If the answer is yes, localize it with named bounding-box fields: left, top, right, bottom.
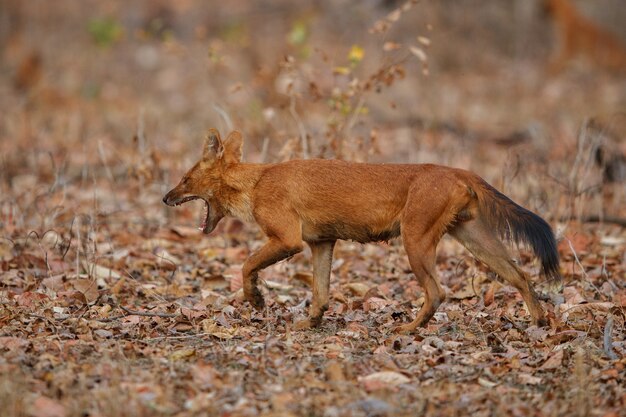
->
left=450, top=219, right=547, bottom=326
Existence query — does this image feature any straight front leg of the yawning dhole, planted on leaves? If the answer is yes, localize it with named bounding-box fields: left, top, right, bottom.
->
left=294, top=240, right=335, bottom=330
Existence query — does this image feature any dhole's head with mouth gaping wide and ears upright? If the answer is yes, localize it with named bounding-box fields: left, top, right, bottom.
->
left=163, top=129, right=243, bottom=233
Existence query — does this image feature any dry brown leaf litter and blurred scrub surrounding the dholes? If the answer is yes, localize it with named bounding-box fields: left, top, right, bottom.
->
left=0, top=0, right=626, bottom=417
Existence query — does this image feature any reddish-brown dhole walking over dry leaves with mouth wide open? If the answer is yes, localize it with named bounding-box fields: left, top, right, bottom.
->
left=163, top=129, right=560, bottom=332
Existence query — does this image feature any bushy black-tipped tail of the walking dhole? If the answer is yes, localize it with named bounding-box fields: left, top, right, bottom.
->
left=474, top=177, right=562, bottom=289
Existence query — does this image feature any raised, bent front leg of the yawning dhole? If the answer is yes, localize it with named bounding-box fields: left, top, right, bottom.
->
left=241, top=238, right=302, bottom=310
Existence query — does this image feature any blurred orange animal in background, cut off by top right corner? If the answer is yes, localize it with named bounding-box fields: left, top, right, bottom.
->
left=544, top=0, right=626, bottom=74
